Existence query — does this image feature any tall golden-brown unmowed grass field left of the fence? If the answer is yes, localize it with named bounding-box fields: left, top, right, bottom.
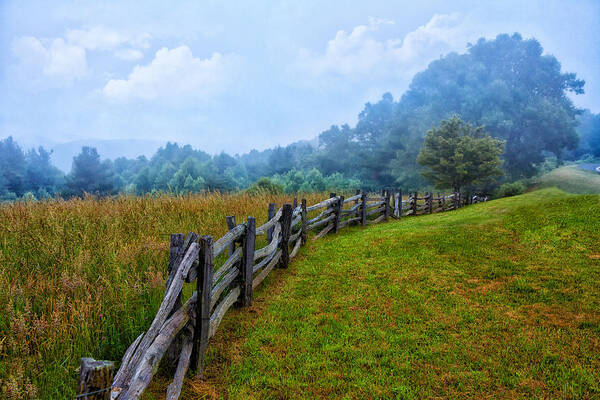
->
left=0, top=194, right=328, bottom=400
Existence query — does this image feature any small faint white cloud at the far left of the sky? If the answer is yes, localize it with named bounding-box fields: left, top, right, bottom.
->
left=12, top=36, right=87, bottom=84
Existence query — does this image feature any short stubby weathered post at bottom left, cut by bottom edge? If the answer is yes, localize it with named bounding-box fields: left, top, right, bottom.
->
left=75, top=357, right=114, bottom=400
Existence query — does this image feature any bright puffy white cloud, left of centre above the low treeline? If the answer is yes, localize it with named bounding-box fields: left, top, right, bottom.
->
left=103, top=46, right=236, bottom=102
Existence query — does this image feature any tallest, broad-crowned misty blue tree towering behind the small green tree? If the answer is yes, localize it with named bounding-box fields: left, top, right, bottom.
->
left=398, top=33, right=584, bottom=179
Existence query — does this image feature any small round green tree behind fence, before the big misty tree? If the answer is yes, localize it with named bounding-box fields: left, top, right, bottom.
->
left=417, top=116, right=504, bottom=192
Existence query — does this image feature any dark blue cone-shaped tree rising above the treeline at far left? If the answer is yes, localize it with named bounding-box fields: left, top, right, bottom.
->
left=63, top=146, right=114, bottom=196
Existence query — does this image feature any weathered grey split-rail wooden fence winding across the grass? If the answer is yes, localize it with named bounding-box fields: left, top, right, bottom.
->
left=77, top=190, right=487, bottom=400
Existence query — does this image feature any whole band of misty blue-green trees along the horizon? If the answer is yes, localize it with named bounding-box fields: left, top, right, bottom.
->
left=0, top=33, right=600, bottom=200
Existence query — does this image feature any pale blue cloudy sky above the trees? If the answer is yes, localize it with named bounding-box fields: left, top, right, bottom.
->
left=0, top=0, right=600, bottom=159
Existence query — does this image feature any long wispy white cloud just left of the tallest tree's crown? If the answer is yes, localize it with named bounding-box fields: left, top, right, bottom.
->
left=294, top=13, right=472, bottom=80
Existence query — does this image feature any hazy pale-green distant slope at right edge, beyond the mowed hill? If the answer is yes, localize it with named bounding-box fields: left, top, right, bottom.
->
left=539, top=165, right=600, bottom=194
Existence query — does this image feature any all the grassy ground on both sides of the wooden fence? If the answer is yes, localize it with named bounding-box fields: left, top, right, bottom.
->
left=0, top=189, right=600, bottom=399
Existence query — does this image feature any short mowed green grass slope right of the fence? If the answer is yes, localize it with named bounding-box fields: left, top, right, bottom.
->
left=179, top=189, right=600, bottom=399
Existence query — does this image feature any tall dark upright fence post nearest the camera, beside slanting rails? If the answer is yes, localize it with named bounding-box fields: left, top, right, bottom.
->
left=191, top=235, right=214, bottom=378
